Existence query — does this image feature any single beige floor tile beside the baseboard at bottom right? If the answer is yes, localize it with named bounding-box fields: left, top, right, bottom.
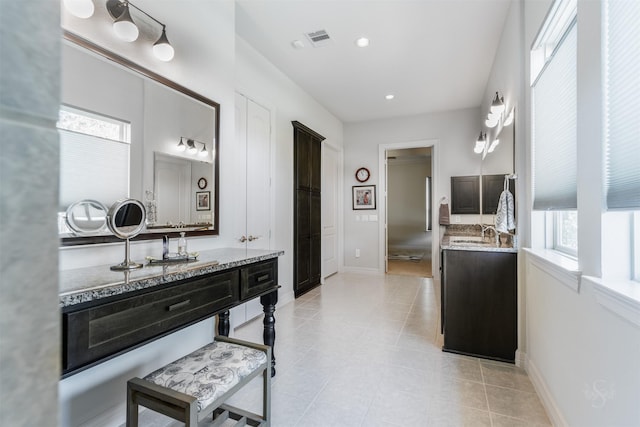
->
left=486, top=385, right=550, bottom=424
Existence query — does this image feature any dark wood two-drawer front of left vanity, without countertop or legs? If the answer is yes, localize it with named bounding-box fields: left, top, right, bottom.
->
left=62, top=259, right=278, bottom=377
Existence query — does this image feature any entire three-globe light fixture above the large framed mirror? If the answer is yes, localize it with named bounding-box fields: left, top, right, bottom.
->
left=64, top=0, right=175, bottom=62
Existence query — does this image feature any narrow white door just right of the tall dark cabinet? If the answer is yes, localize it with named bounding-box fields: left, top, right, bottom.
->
left=322, top=144, right=340, bottom=279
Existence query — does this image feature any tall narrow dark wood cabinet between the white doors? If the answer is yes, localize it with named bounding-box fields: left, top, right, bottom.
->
left=291, top=121, right=324, bottom=297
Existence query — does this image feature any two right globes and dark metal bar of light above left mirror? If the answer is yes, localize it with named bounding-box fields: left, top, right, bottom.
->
left=106, top=0, right=175, bottom=62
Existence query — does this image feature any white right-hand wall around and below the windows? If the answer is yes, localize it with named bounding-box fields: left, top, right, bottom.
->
left=520, top=0, right=640, bottom=426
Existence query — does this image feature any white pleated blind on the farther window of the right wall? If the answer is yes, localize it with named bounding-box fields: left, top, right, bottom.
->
left=532, top=22, right=577, bottom=210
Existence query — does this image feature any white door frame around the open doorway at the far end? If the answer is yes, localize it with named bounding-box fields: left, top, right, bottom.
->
left=378, top=139, right=440, bottom=277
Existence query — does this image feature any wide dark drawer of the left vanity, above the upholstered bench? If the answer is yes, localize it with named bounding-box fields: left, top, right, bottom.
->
left=63, top=270, right=240, bottom=372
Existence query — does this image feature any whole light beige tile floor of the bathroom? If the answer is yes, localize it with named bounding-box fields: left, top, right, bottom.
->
left=136, top=273, right=551, bottom=427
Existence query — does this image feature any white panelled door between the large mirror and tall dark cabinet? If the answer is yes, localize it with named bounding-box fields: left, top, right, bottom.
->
left=231, top=93, right=271, bottom=329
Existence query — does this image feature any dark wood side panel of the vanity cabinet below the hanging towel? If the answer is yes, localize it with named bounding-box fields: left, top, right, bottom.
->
left=441, top=249, right=518, bottom=362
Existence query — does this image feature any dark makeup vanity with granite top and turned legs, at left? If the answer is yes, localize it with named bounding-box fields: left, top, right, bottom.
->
left=60, top=249, right=283, bottom=378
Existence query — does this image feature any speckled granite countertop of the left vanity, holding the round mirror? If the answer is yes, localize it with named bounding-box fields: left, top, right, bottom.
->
left=59, top=248, right=284, bottom=307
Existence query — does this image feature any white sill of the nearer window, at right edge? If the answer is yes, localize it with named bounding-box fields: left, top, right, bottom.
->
left=584, top=276, right=640, bottom=327
